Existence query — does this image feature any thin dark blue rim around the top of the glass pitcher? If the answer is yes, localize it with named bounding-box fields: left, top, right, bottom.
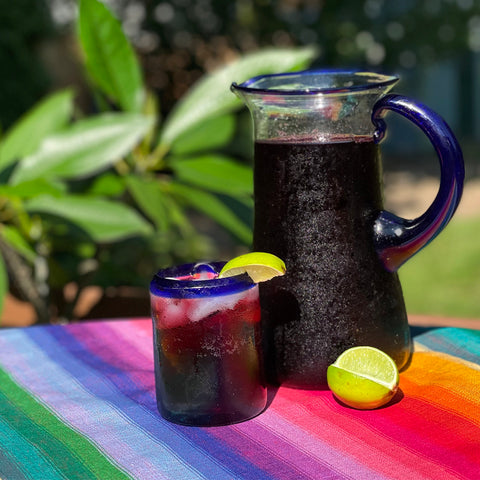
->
left=231, top=69, right=399, bottom=95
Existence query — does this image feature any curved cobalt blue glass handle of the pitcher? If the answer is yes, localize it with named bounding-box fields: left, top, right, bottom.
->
left=372, top=94, right=465, bottom=272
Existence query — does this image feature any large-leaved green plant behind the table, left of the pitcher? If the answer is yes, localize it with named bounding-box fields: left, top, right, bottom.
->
left=0, top=0, right=315, bottom=322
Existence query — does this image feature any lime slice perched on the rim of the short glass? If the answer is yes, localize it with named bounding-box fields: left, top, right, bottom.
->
left=218, top=252, right=286, bottom=283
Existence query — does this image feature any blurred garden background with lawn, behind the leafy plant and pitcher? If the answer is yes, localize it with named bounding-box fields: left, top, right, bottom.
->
left=0, top=0, right=480, bottom=326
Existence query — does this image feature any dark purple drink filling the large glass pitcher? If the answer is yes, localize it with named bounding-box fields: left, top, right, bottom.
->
left=254, top=137, right=410, bottom=386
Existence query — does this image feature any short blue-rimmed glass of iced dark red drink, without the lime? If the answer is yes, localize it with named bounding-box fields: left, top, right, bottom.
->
left=150, top=263, right=267, bottom=426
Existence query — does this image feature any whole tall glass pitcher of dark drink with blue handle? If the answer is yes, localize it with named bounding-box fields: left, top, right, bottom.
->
left=232, top=71, right=464, bottom=389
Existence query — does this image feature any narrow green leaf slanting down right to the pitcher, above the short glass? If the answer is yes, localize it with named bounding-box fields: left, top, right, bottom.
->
left=170, top=183, right=252, bottom=245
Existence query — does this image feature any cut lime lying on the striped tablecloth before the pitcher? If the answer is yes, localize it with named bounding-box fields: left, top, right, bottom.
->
left=327, top=347, right=399, bottom=410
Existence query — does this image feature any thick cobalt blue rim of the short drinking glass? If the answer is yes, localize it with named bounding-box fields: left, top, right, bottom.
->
left=150, top=262, right=256, bottom=298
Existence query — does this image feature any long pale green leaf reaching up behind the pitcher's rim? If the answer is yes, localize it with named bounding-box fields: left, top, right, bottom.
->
left=161, top=47, right=316, bottom=145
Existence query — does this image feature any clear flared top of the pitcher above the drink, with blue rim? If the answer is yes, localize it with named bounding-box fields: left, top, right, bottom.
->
left=231, top=70, right=398, bottom=142
